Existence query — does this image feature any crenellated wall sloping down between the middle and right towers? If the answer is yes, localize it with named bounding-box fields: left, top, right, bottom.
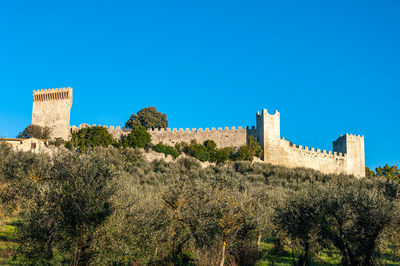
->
left=266, top=139, right=347, bottom=174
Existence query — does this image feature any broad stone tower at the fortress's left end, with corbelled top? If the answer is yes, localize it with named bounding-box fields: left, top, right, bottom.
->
left=32, top=87, right=72, bottom=139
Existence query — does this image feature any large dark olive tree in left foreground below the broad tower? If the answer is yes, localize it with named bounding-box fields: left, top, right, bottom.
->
left=19, top=152, right=115, bottom=265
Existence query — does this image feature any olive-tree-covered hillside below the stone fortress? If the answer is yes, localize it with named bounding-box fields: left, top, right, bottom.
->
left=0, top=143, right=400, bottom=265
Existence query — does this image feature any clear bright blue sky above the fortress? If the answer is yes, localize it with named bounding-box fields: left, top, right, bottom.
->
left=0, top=0, right=400, bottom=168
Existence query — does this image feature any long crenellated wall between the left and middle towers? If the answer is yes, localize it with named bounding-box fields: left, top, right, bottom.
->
left=71, top=124, right=256, bottom=148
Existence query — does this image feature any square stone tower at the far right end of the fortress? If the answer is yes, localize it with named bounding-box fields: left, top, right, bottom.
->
left=333, top=134, right=365, bottom=177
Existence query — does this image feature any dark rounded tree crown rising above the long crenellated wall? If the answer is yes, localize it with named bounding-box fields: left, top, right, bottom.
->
left=125, top=107, right=168, bottom=129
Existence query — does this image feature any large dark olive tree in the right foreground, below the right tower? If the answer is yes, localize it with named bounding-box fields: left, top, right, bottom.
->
left=276, top=180, right=399, bottom=265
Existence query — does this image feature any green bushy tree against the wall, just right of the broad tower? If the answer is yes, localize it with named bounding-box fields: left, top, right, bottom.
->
left=65, top=126, right=115, bottom=152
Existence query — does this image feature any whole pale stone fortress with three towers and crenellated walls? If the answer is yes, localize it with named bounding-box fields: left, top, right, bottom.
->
left=32, top=88, right=365, bottom=177
